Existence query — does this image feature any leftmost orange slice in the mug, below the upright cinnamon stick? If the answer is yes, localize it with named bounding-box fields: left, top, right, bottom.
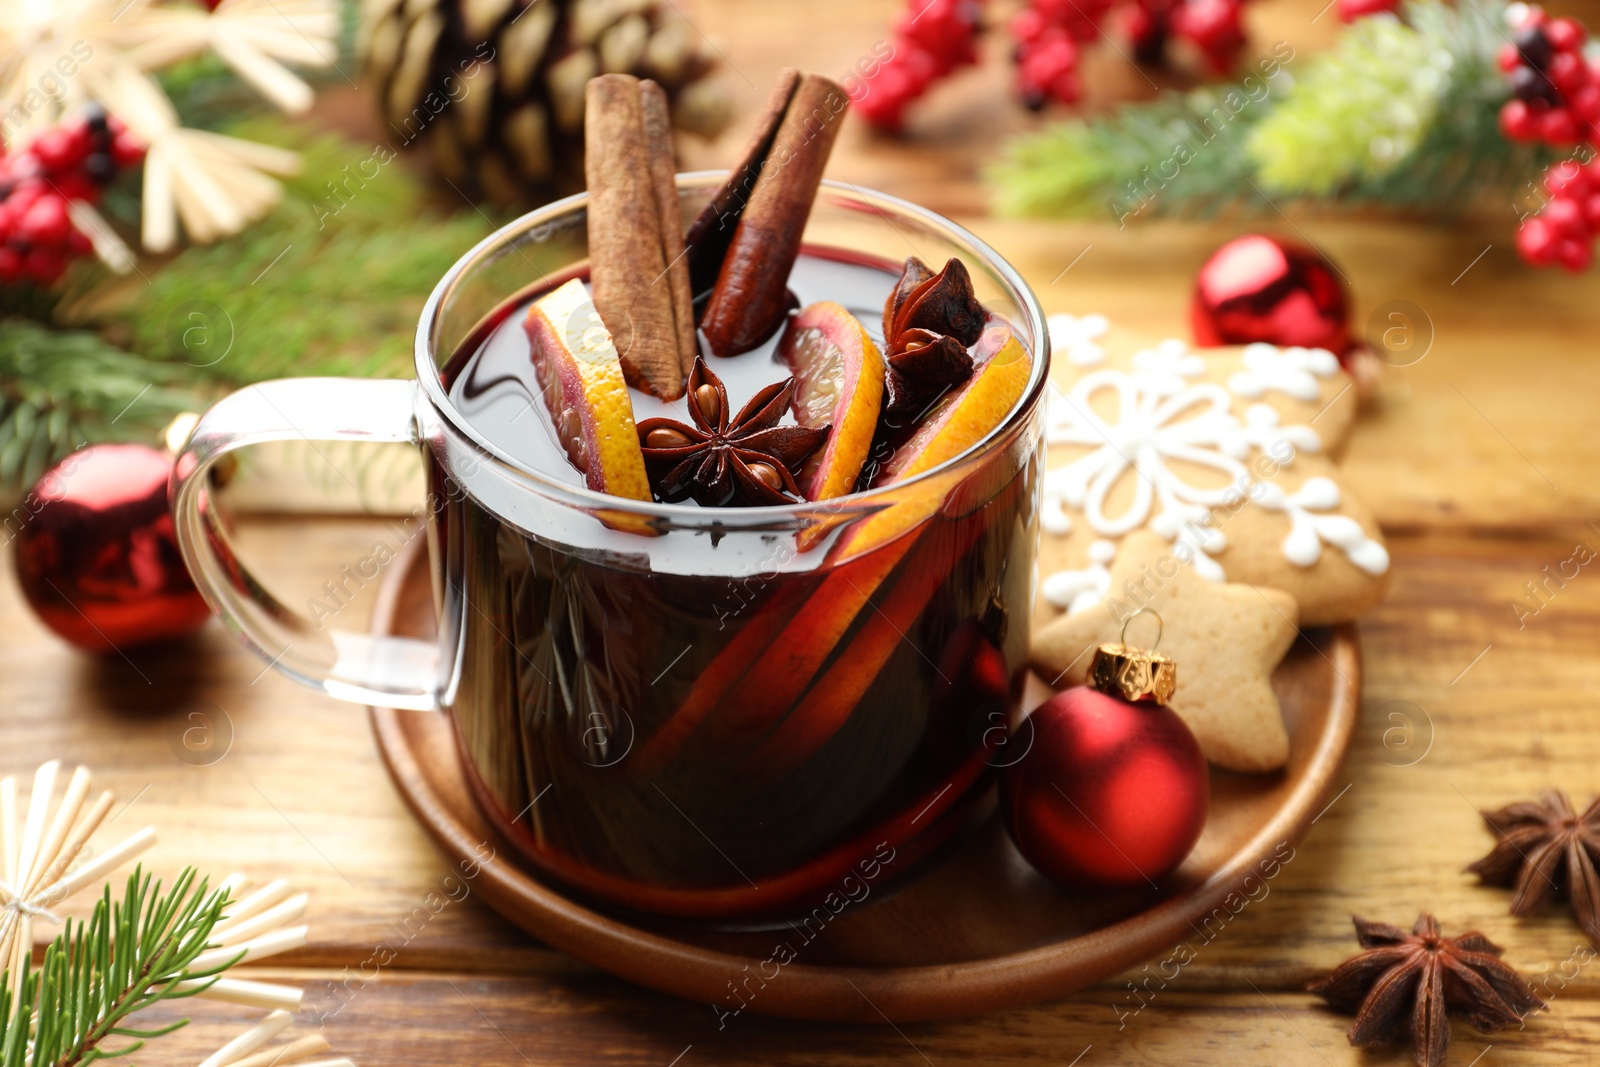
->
left=526, top=278, right=650, bottom=501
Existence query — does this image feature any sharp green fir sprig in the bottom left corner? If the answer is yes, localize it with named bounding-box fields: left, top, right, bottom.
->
left=0, top=869, right=232, bottom=1067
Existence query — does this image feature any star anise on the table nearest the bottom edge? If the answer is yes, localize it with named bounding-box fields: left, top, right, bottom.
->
left=1307, top=913, right=1544, bottom=1067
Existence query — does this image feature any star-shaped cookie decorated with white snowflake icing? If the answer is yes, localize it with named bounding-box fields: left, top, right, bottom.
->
left=1035, top=326, right=1389, bottom=625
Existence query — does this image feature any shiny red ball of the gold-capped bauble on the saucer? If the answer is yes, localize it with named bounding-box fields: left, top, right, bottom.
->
left=1000, top=686, right=1211, bottom=889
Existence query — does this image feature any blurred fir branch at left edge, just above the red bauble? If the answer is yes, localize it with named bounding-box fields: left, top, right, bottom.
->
left=0, top=320, right=202, bottom=488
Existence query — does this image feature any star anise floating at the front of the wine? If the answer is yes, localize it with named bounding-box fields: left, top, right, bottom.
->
left=638, top=358, right=829, bottom=507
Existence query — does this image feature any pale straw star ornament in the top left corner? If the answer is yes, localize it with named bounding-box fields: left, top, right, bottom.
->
left=0, top=0, right=339, bottom=254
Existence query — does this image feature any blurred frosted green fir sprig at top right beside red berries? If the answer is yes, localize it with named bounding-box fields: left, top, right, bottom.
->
left=990, top=0, right=1550, bottom=222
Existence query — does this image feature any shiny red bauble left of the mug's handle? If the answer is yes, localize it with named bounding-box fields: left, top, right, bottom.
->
left=14, top=445, right=211, bottom=653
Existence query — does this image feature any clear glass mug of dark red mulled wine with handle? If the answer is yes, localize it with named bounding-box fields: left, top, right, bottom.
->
left=173, top=173, right=1050, bottom=921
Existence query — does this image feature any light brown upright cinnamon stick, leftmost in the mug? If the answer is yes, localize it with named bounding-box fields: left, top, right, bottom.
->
left=584, top=74, right=685, bottom=400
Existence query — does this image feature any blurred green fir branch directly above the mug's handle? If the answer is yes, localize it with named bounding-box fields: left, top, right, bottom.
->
left=92, top=118, right=512, bottom=386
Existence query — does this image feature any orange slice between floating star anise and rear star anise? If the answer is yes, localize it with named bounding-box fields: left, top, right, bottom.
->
left=778, top=301, right=883, bottom=501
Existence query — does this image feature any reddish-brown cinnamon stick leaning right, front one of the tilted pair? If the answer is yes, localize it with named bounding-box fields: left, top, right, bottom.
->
left=701, top=74, right=850, bottom=355
